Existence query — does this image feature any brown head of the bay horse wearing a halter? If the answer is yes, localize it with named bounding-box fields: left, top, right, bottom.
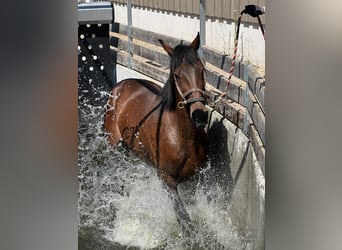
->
left=159, top=33, right=208, bottom=128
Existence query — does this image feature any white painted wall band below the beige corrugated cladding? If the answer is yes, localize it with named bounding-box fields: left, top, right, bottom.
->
left=114, top=4, right=265, bottom=67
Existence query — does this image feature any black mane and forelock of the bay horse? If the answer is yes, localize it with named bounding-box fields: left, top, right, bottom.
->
left=160, top=45, right=198, bottom=110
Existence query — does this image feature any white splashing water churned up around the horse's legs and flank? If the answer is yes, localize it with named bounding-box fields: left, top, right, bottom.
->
left=78, top=83, right=251, bottom=249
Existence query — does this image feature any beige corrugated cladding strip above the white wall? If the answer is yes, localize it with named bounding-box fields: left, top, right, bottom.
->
left=112, top=0, right=266, bottom=23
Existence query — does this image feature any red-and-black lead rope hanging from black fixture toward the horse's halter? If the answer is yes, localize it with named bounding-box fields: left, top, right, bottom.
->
left=209, top=5, right=265, bottom=107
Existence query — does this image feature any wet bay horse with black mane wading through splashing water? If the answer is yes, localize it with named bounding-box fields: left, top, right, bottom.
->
left=104, top=33, right=208, bottom=231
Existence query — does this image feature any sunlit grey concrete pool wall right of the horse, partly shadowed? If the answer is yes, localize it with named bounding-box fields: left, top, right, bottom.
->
left=208, top=107, right=265, bottom=249
